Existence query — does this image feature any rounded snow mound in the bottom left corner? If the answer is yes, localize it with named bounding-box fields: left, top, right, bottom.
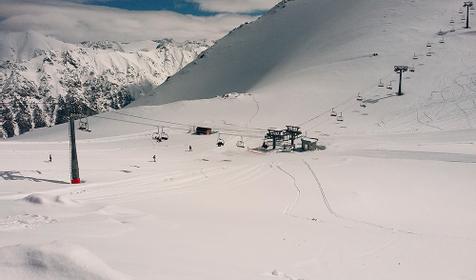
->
left=0, top=242, right=129, bottom=280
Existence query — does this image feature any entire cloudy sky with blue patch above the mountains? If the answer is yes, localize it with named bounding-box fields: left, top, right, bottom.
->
left=0, top=0, right=278, bottom=42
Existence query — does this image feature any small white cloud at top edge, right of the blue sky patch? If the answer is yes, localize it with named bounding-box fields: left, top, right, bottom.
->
left=190, top=0, right=279, bottom=13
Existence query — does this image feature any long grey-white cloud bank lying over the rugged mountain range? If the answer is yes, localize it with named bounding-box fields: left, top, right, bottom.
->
left=0, top=0, right=254, bottom=42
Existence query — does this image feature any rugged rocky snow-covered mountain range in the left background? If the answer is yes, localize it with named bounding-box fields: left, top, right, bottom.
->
left=0, top=32, right=211, bottom=137
